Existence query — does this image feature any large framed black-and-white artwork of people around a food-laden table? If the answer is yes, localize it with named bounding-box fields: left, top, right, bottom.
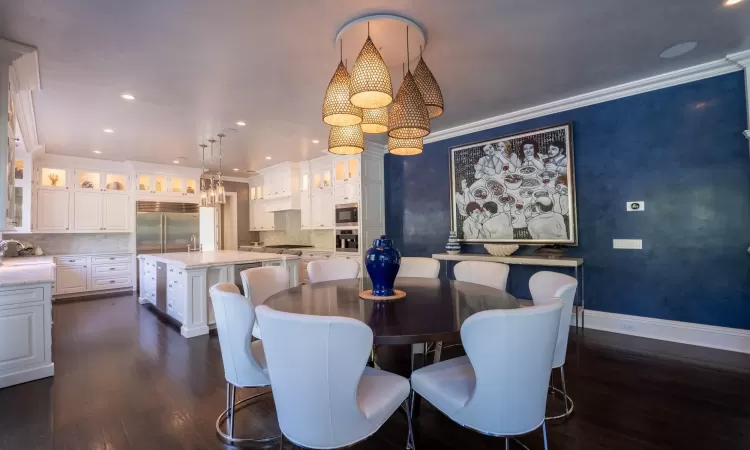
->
left=450, top=123, right=578, bottom=245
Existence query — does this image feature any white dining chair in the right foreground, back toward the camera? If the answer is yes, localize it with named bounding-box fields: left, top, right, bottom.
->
left=411, top=300, right=562, bottom=449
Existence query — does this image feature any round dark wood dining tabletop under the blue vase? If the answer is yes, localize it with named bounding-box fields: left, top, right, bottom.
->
left=264, top=278, right=519, bottom=344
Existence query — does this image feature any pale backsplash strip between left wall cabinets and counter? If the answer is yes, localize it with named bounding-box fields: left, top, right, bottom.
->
left=3, top=233, right=132, bottom=255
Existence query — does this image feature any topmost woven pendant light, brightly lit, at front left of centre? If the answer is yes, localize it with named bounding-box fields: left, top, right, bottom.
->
left=349, top=22, right=393, bottom=109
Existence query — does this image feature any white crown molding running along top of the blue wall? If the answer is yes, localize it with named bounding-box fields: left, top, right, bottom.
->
left=424, top=55, right=750, bottom=144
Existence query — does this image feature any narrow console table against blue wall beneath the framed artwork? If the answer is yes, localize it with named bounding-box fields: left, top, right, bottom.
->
left=432, top=253, right=586, bottom=329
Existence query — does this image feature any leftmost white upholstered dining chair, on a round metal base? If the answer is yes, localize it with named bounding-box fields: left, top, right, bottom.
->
left=209, top=283, right=280, bottom=445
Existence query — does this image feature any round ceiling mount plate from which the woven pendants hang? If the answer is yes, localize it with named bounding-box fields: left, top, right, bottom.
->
left=333, top=14, right=427, bottom=70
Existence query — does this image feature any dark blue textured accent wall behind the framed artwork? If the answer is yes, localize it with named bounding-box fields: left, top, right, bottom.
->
left=385, top=72, right=750, bottom=329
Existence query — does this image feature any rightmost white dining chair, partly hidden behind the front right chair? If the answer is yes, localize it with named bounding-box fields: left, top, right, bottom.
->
left=529, top=272, right=578, bottom=419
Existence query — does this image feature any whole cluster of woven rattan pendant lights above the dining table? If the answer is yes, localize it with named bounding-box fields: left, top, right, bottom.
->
left=323, top=22, right=444, bottom=156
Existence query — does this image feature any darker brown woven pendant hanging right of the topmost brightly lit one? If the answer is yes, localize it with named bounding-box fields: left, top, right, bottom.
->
left=388, top=27, right=430, bottom=139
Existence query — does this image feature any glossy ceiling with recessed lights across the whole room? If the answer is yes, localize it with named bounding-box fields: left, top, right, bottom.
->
left=0, top=0, right=750, bottom=170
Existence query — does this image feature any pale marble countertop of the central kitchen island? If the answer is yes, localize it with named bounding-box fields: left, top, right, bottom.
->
left=138, top=250, right=300, bottom=269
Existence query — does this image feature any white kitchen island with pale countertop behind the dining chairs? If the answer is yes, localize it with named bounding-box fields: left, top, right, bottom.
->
left=138, top=250, right=300, bottom=338
